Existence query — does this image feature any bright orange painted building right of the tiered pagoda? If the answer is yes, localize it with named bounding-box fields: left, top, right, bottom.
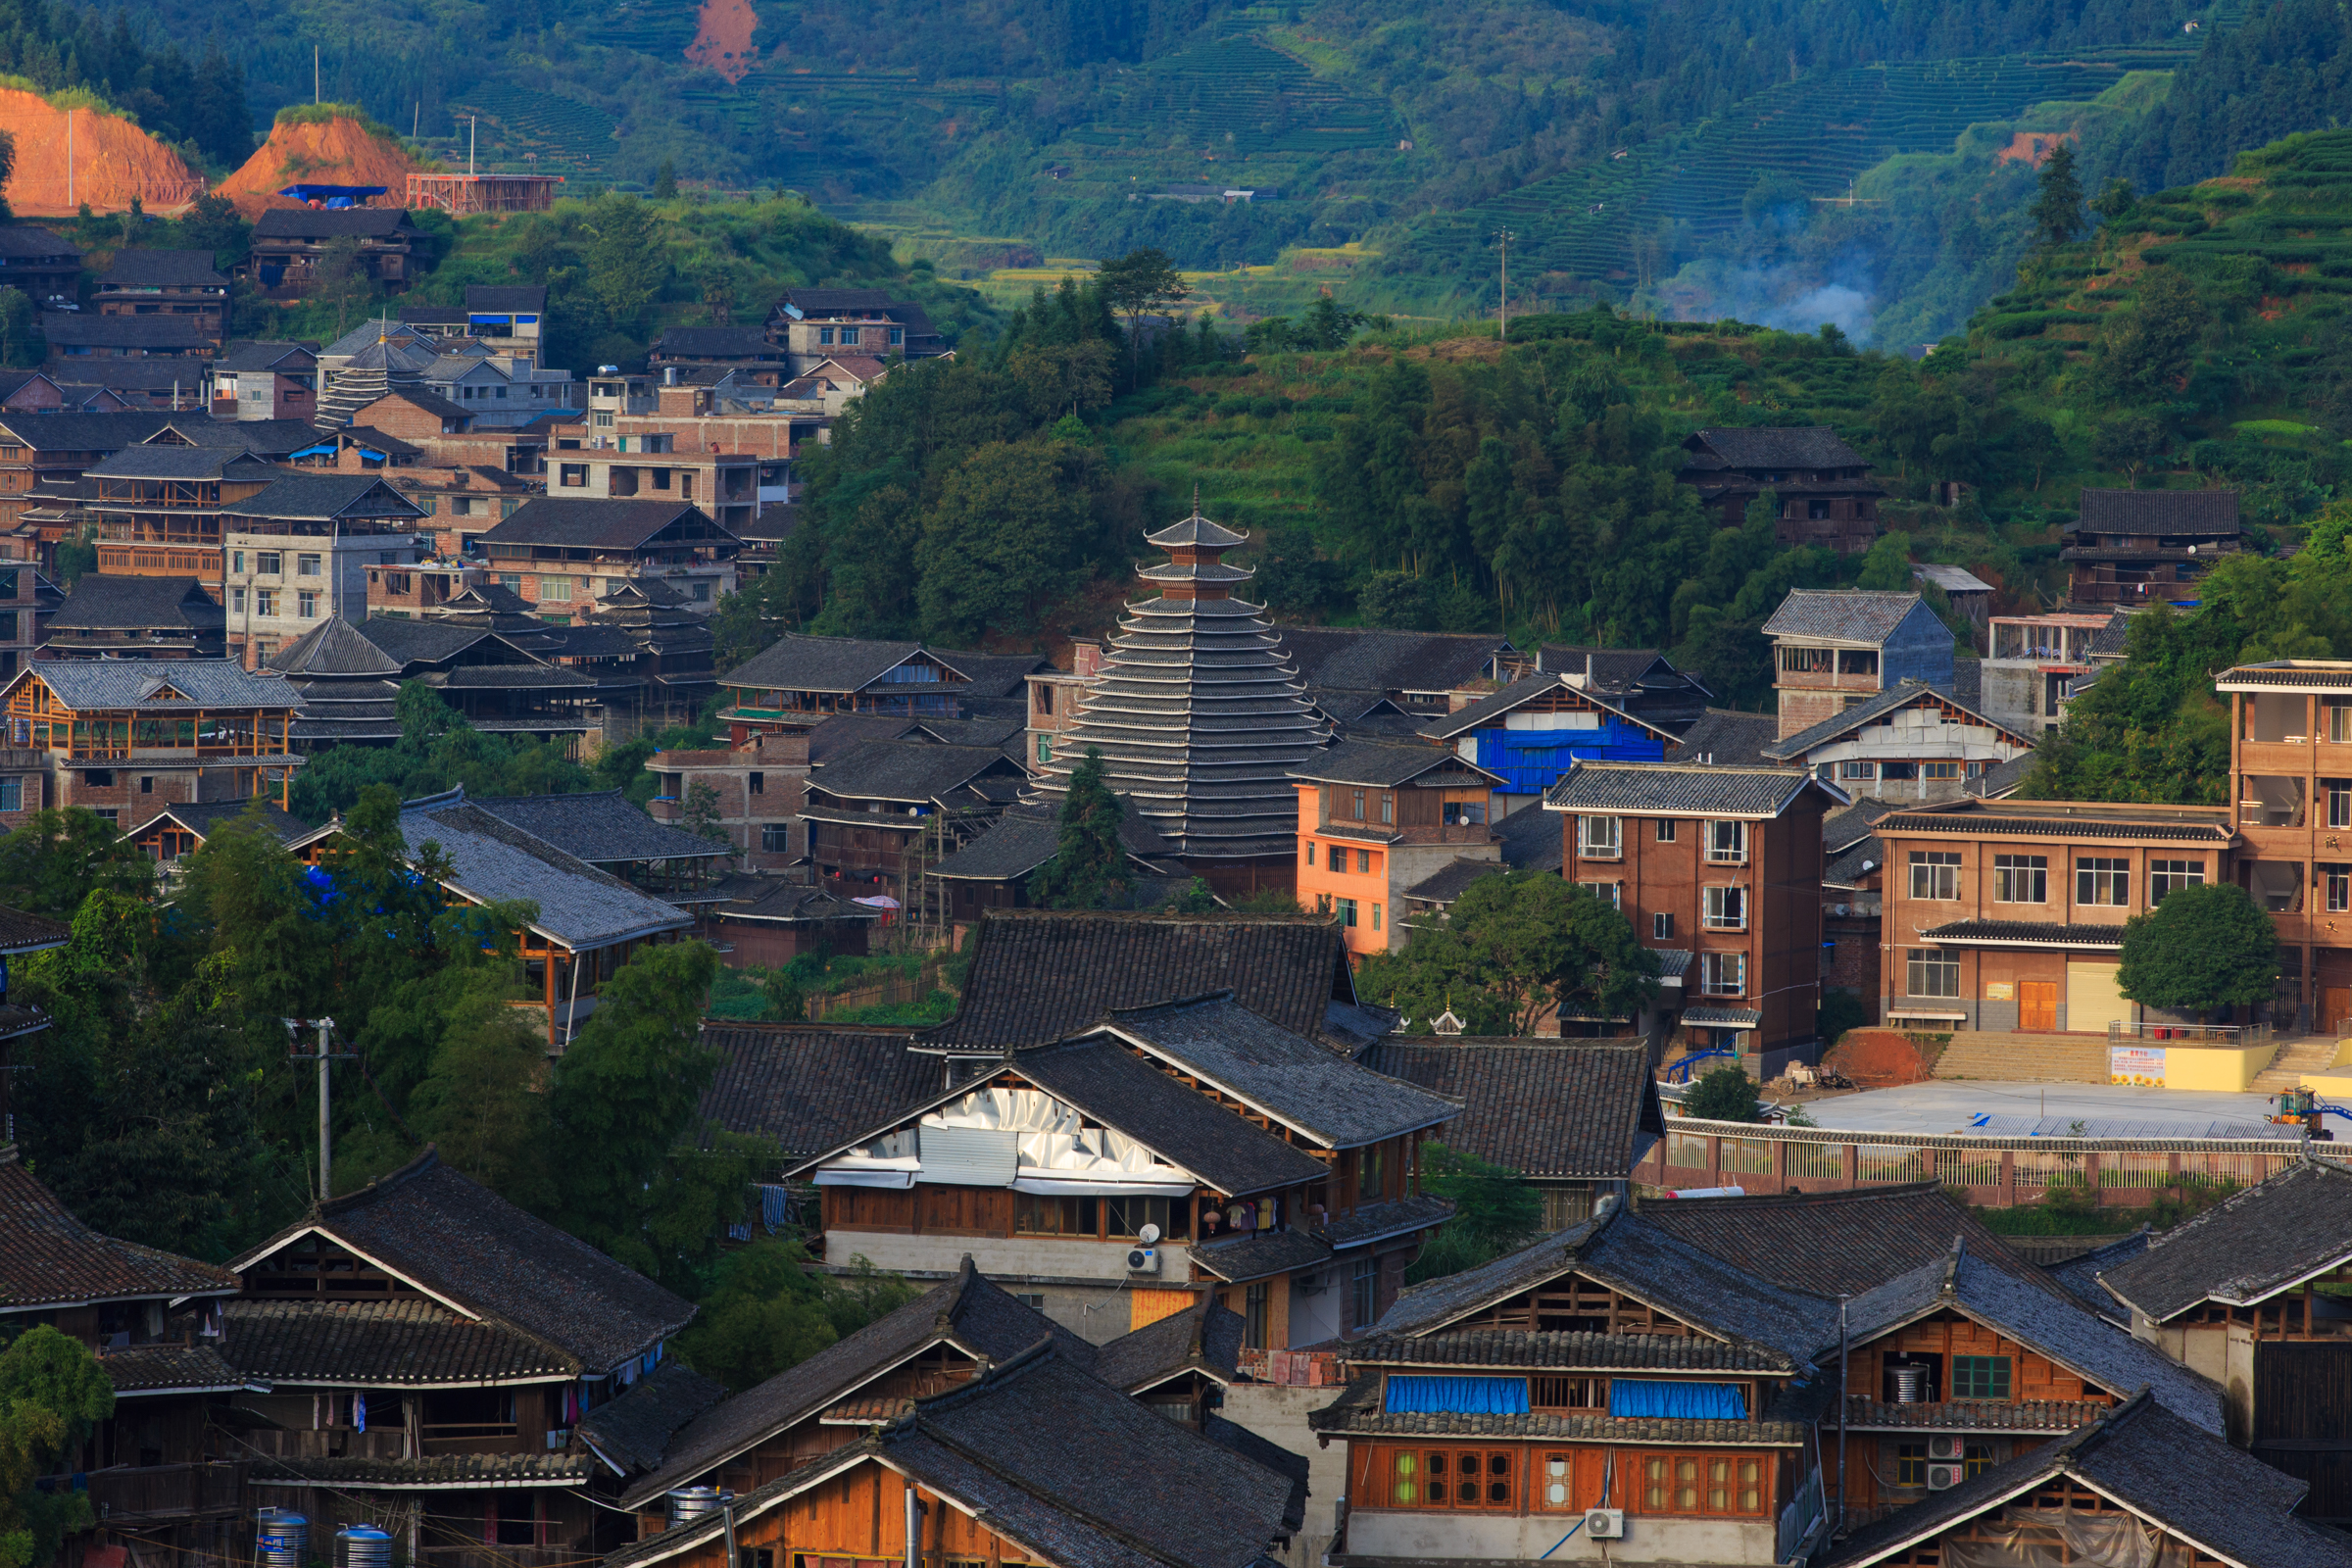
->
left=1292, top=741, right=1503, bottom=959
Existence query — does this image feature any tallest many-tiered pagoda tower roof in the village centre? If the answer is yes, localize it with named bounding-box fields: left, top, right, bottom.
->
left=1033, top=499, right=1327, bottom=860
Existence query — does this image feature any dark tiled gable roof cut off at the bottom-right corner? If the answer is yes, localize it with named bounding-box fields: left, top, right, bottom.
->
left=1828, top=1394, right=2352, bottom=1568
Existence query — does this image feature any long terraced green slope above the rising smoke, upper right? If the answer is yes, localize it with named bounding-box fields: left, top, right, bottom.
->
left=1413, top=52, right=2145, bottom=282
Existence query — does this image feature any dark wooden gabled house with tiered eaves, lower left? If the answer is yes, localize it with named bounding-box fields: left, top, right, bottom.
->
left=223, top=1148, right=694, bottom=1568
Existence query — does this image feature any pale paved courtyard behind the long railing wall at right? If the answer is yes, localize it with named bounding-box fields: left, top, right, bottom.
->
left=1768, top=1079, right=2352, bottom=1152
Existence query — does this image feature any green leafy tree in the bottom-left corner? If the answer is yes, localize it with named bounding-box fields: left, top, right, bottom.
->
left=0, top=1324, right=116, bottom=1568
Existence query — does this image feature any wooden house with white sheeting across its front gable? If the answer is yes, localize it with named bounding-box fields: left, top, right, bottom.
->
left=790, top=987, right=1460, bottom=1349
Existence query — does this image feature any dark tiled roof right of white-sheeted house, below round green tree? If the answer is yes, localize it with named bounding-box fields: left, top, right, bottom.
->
left=1364, top=1034, right=1665, bottom=1180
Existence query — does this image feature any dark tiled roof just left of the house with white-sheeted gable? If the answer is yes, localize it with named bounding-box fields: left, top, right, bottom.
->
left=701, top=1020, right=943, bottom=1159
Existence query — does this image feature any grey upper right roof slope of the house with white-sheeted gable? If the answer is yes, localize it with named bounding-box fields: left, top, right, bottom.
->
left=1105, top=990, right=1460, bottom=1150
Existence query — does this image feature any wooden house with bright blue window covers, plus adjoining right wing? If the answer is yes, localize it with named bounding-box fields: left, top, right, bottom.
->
left=1312, top=1185, right=2230, bottom=1566
